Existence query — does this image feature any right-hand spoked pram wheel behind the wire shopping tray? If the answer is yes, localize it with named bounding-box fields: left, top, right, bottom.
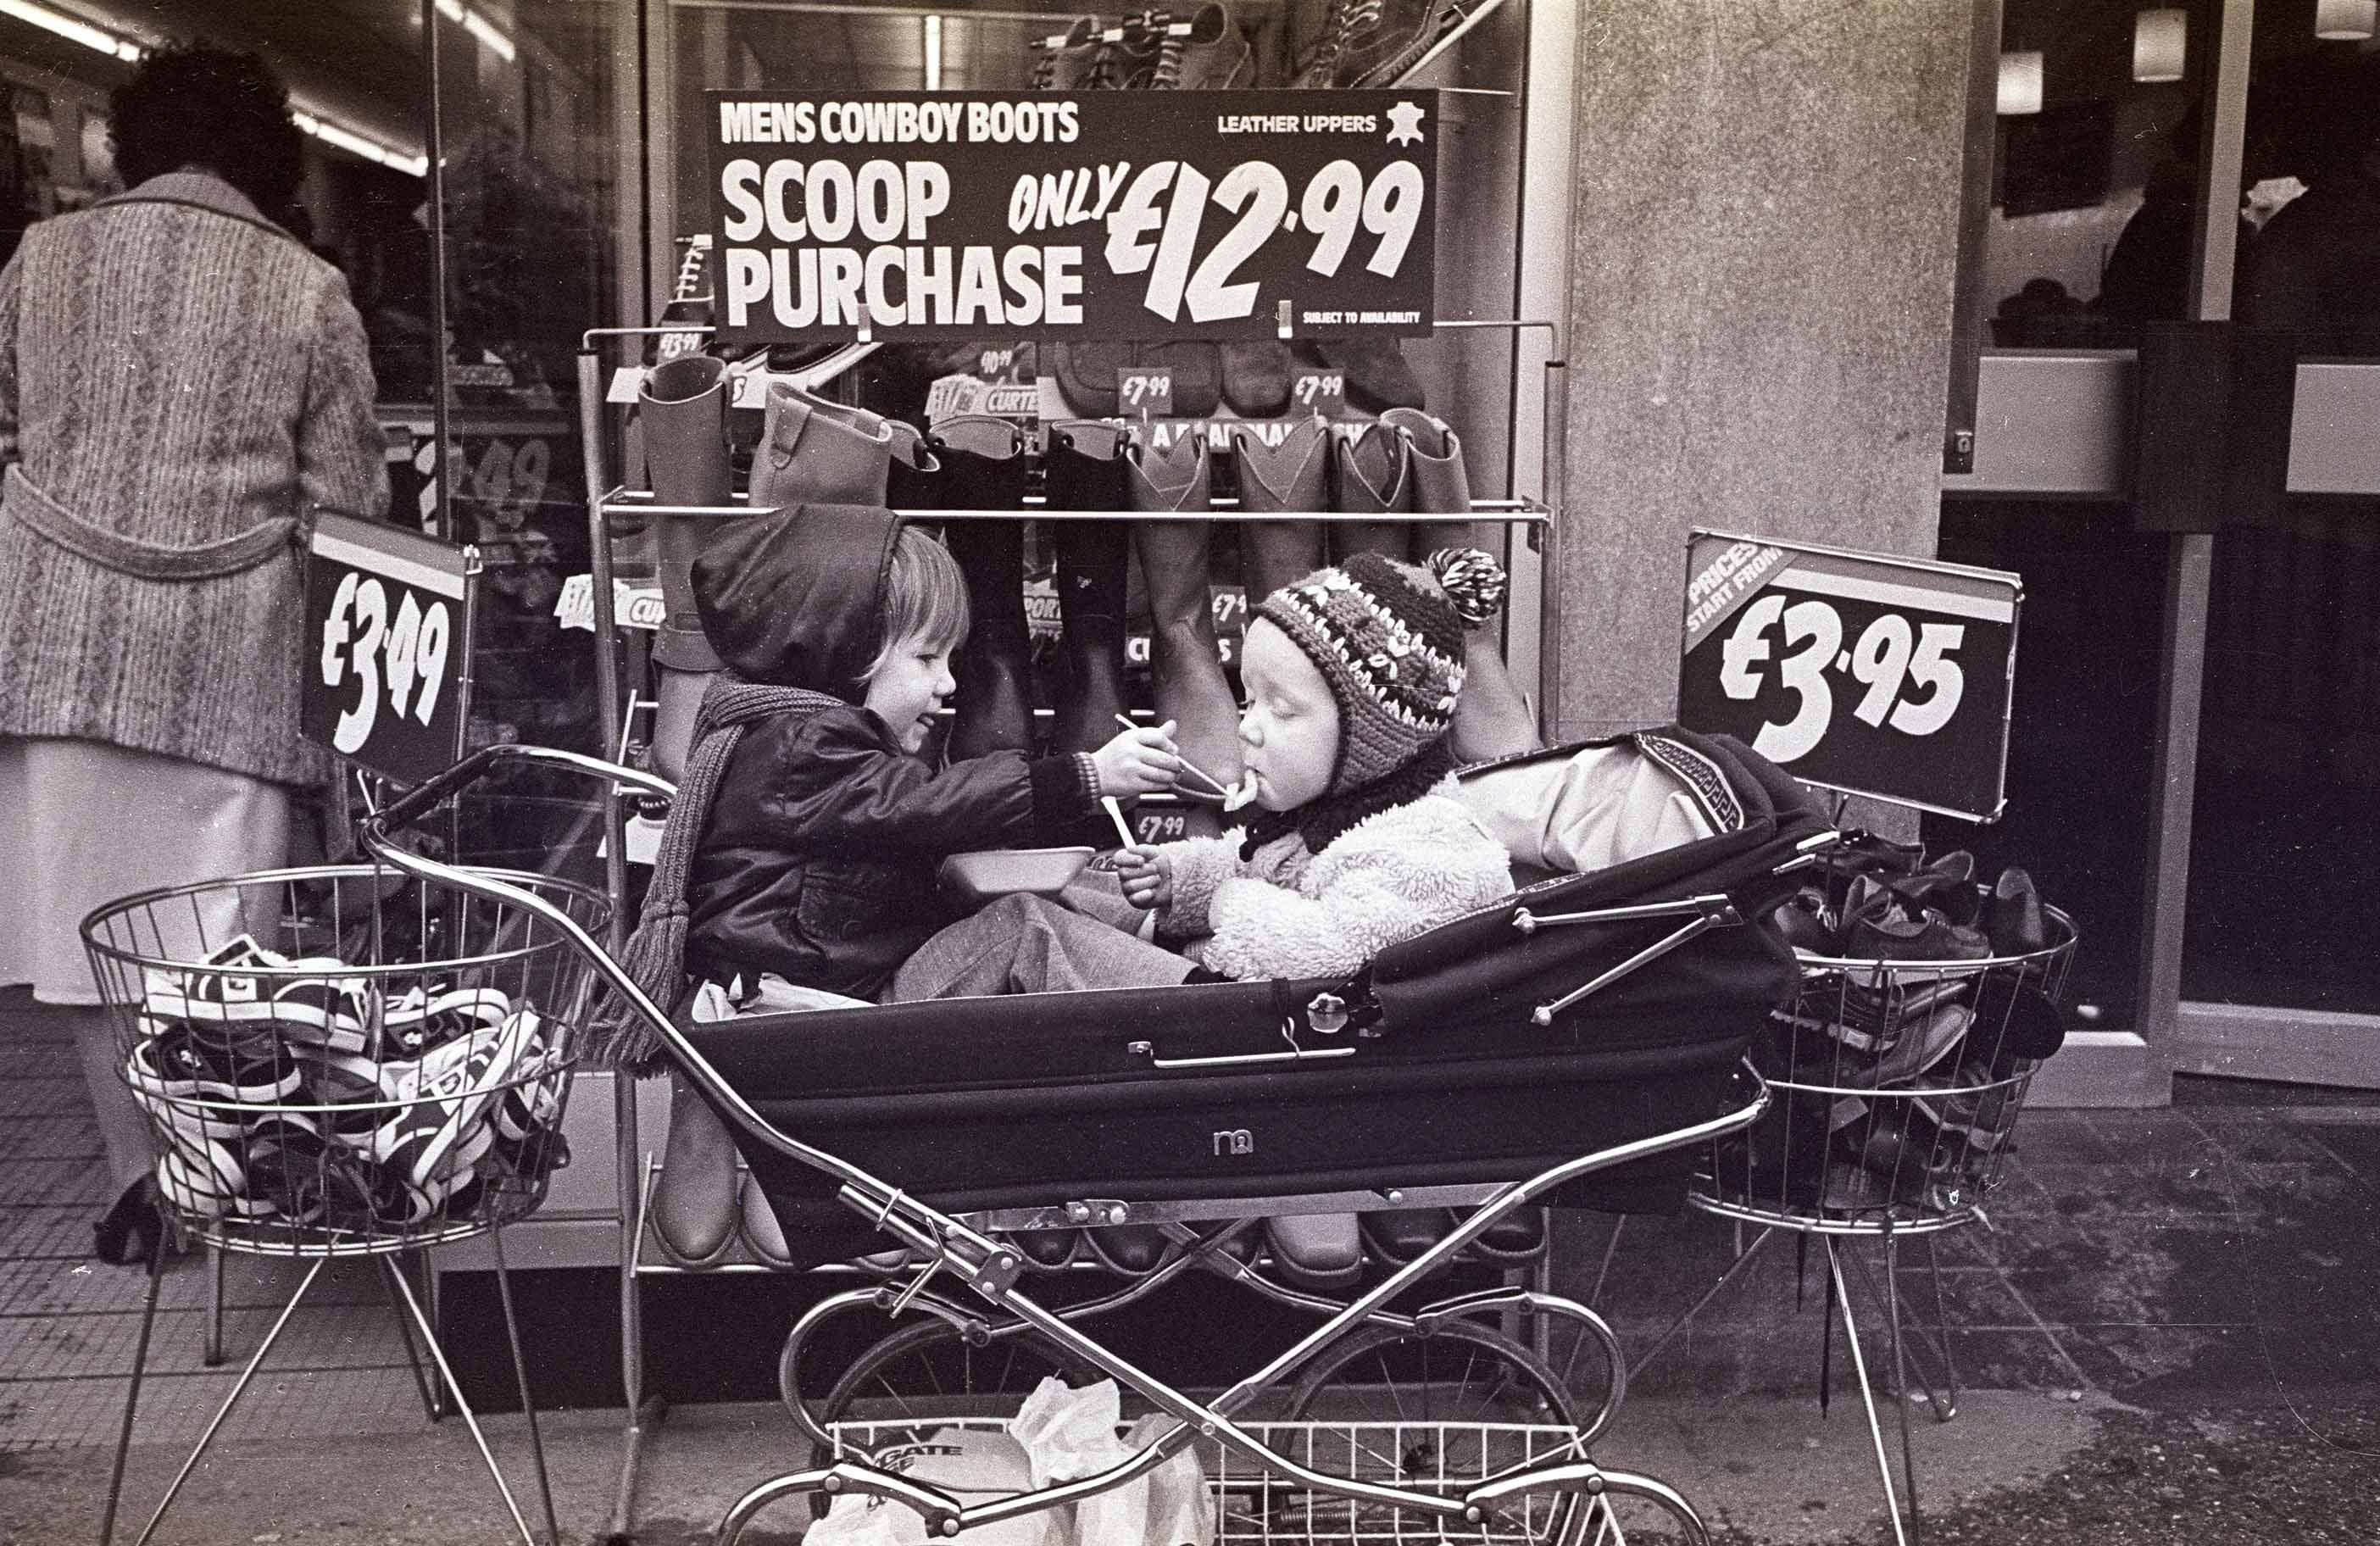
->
left=1271, top=1320, right=1582, bottom=1546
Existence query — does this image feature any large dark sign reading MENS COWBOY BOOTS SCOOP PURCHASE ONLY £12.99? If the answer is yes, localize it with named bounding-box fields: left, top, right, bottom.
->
left=698, top=91, right=1440, bottom=348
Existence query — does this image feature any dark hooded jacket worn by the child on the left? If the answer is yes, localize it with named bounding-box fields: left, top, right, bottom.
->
left=686, top=504, right=1097, bottom=999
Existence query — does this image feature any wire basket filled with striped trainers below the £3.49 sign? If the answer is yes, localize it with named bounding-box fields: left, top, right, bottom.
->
left=83, top=865, right=607, bottom=1256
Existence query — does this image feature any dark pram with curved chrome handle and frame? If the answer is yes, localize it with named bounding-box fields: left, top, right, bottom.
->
left=364, top=730, right=1832, bottom=1543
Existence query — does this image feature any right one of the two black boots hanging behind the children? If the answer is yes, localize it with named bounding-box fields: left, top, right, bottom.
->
left=1043, top=419, right=1133, bottom=754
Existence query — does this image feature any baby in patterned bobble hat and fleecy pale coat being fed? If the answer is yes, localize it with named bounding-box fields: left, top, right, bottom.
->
left=892, top=549, right=1511, bottom=1001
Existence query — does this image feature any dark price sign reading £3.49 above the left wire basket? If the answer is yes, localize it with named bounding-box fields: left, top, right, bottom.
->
left=298, top=514, right=478, bottom=782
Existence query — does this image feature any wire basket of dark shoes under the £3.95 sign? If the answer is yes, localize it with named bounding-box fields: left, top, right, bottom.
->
left=1694, top=909, right=2076, bottom=1234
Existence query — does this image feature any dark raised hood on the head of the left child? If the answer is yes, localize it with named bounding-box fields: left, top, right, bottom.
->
left=692, top=504, right=902, bottom=704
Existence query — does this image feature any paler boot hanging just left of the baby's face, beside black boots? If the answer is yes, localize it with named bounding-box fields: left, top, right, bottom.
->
left=1123, top=420, right=1240, bottom=830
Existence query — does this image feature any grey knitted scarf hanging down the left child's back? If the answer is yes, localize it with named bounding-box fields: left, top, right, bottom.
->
left=586, top=673, right=842, bottom=1073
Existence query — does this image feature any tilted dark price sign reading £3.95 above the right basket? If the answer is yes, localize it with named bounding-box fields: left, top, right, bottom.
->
left=1678, top=531, right=2023, bottom=820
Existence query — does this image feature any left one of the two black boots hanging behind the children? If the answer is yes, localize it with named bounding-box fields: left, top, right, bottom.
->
left=932, top=414, right=1033, bottom=761
